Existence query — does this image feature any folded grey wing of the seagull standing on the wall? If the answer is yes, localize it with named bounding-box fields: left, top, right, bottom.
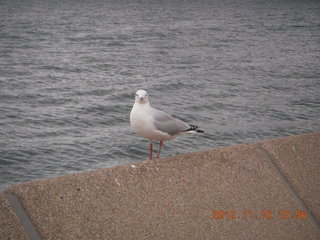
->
left=152, top=108, right=190, bottom=135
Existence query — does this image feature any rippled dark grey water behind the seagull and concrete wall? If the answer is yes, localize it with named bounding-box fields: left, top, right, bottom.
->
left=0, top=0, right=320, bottom=189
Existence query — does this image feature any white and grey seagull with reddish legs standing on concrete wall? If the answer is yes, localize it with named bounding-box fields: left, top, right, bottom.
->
left=130, top=90, right=203, bottom=160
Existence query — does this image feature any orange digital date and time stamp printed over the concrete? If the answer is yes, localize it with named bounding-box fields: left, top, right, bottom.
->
left=210, top=210, right=308, bottom=220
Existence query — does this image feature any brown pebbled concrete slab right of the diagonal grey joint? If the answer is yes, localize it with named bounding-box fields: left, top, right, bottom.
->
left=262, top=134, right=320, bottom=222
